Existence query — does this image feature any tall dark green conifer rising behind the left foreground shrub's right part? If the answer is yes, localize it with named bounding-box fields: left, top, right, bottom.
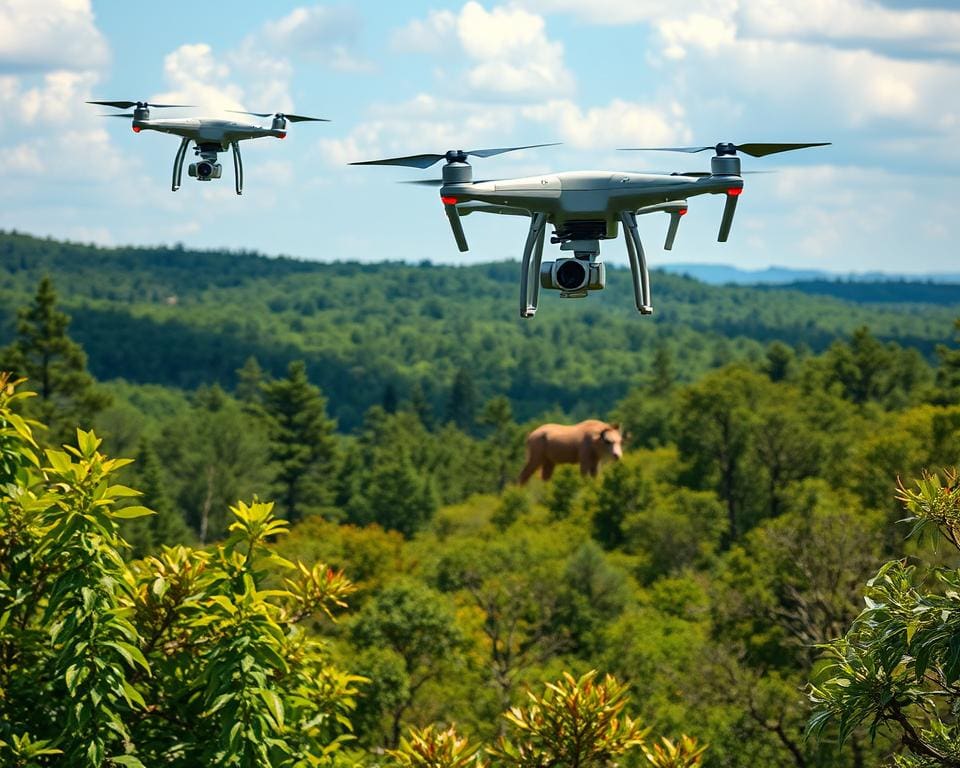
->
left=263, top=360, right=336, bottom=521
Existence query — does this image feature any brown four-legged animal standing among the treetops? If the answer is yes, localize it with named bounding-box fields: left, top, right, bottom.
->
left=519, top=419, right=623, bottom=485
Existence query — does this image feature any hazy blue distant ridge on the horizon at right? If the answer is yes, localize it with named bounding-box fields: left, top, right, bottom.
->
left=660, top=264, right=960, bottom=285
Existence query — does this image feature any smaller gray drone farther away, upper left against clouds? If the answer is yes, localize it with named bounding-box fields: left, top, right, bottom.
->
left=87, top=101, right=330, bottom=195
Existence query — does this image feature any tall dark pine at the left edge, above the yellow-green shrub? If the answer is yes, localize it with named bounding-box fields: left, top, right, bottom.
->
left=0, top=277, right=110, bottom=443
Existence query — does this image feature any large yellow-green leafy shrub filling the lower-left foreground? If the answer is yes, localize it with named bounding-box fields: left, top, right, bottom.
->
left=0, top=378, right=359, bottom=767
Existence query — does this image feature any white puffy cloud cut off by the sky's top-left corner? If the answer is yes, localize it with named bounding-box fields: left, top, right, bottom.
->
left=0, top=0, right=109, bottom=72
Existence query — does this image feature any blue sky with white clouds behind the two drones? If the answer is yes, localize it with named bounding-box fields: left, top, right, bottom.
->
left=0, top=0, right=960, bottom=273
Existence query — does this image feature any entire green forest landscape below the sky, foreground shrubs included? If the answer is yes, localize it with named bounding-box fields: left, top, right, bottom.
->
left=0, top=234, right=960, bottom=768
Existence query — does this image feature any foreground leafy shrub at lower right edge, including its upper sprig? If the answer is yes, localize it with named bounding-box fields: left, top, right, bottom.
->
left=809, top=470, right=960, bottom=768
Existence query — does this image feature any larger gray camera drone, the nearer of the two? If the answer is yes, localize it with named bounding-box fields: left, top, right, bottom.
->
left=351, top=142, right=830, bottom=317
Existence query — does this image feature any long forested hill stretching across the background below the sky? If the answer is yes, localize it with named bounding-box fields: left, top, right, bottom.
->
left=0, top=233, right=960, bottom=429
